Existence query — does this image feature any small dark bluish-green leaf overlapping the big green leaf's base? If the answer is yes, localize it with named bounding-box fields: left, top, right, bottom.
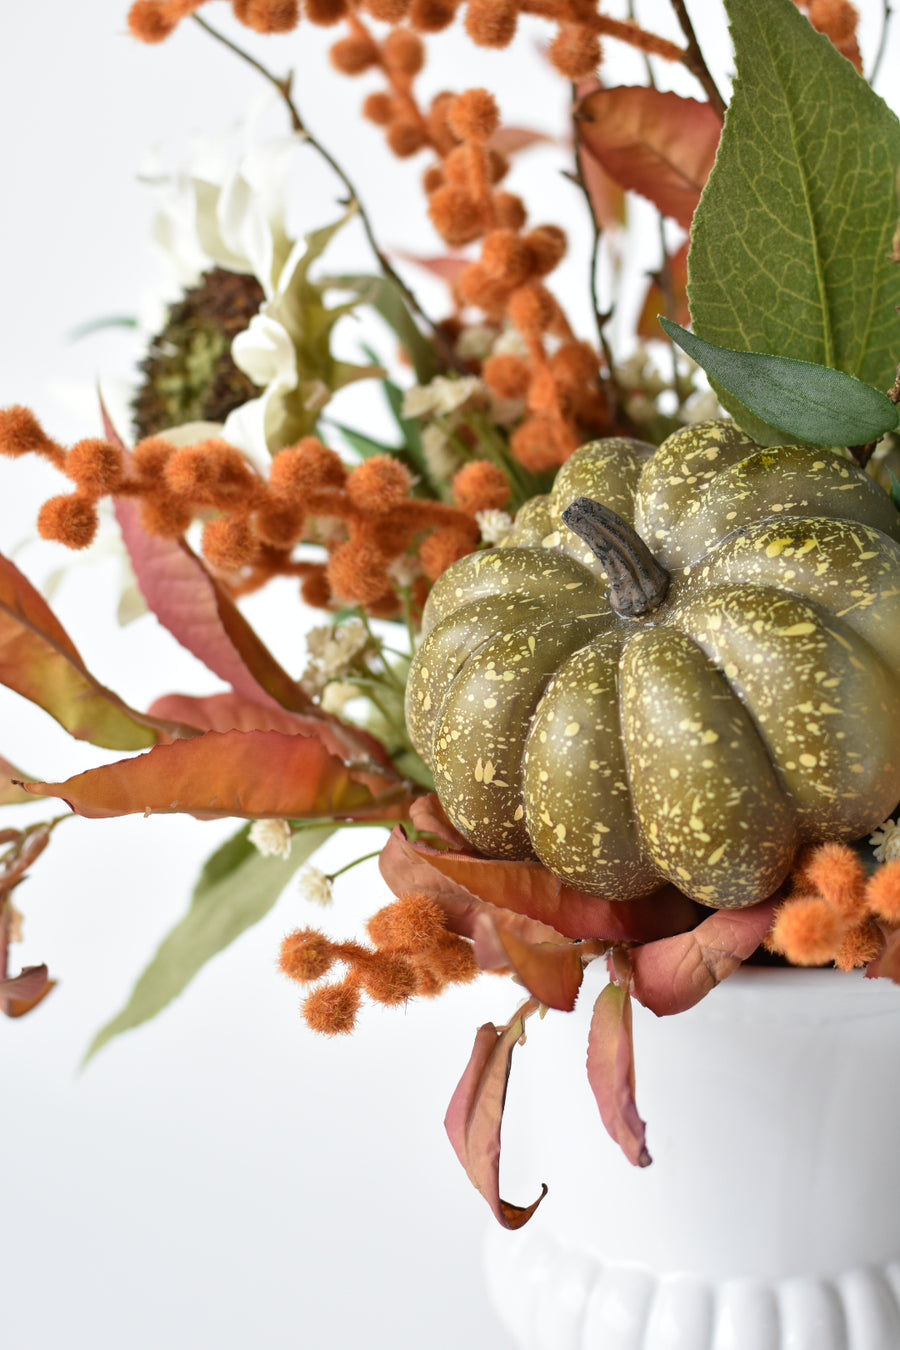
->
left=660, top=315, right=899, bottom=446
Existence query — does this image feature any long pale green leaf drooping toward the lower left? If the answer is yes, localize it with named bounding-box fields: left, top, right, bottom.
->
left=82, top=825, right=336, bottom=1067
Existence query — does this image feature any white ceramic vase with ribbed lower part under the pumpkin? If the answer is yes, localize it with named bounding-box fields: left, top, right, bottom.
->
left=486, top=961, right=900, bottom=1350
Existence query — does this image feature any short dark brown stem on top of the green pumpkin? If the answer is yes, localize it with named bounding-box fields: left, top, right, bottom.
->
left=563, top=497, right=669, bottom=618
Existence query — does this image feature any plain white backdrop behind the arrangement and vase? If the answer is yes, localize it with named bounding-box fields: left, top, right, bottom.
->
left=0, top=0, right=897, bottom=1350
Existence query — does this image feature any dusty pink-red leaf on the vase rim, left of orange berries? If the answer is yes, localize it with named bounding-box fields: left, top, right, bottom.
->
left=631, top=899, right=779, bottom=1017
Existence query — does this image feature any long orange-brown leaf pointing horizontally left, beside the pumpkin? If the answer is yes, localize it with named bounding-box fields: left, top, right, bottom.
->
left=24, top=732, right=409, bottom=819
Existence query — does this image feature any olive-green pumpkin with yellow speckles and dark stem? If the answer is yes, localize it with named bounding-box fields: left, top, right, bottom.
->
left=406, top=421, right=900, bottom=907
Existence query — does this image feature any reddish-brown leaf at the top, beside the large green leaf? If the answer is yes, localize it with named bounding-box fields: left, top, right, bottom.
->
left=578, top=85, right=722, bottom=230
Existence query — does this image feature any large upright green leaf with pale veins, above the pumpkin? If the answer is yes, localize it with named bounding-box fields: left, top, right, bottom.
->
left=688, top=0, right=900, bottom=413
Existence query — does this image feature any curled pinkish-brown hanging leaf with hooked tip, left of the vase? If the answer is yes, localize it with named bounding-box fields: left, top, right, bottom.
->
left=444, top=1008, right=546, bottom=1229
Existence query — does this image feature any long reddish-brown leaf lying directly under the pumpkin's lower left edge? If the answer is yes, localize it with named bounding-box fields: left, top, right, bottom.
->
left=382, top=820, right=698, bottom=942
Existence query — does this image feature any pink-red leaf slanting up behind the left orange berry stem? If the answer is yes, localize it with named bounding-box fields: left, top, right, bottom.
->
left=116, top=498, right=313, bottom=713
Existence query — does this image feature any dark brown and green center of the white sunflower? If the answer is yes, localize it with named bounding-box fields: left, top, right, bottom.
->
left=131, top=267, right=266, bottom=439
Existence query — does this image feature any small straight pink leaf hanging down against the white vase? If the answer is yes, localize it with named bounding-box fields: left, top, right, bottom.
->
left=587, top=984, right=652, bottom=1168
